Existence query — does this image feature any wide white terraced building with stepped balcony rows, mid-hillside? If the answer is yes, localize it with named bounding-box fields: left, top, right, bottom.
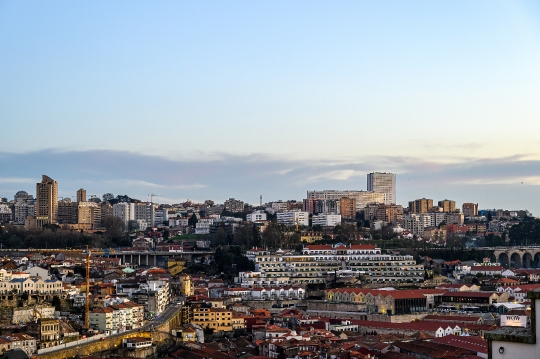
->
left=236, top=244, right=424, bottom=288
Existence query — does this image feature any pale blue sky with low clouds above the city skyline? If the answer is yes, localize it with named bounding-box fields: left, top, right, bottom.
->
left=0, top=1, right=540, bottom=215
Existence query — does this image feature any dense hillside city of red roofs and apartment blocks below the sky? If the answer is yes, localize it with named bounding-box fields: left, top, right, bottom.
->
left=0, top=172, right=540, bottom=359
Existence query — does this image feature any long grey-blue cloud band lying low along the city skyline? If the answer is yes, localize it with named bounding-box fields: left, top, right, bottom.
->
left=0, top=150, right=540, bottom=212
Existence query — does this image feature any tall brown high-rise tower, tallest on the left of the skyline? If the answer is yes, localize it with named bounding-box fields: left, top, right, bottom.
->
left=35, top=175, right=58, bottom=228
